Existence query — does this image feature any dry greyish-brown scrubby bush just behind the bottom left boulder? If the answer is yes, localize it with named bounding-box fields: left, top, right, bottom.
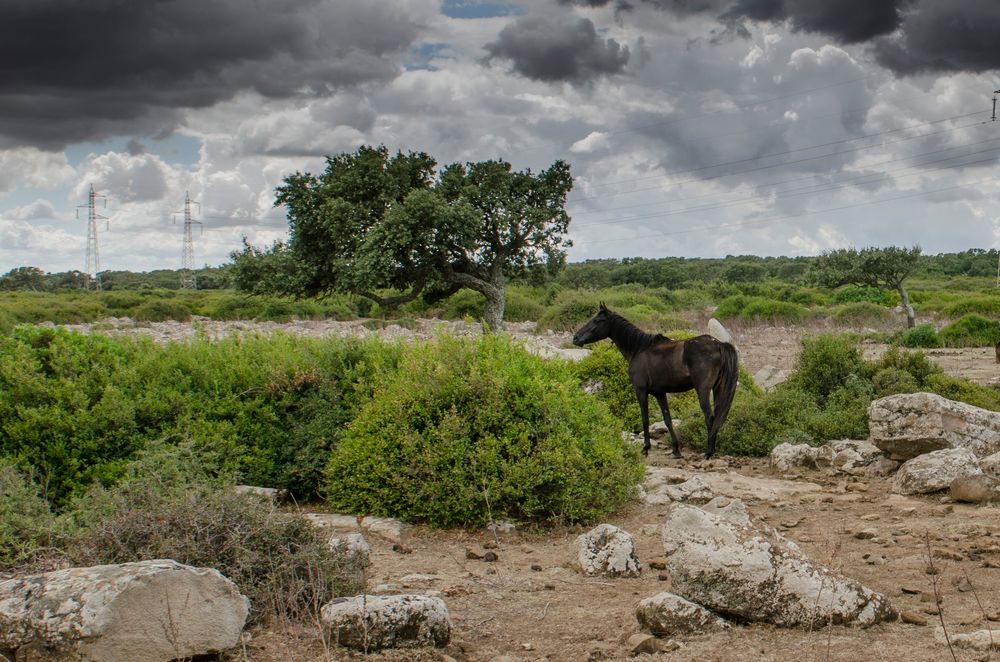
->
left=69, top=447, right=364, bottom=621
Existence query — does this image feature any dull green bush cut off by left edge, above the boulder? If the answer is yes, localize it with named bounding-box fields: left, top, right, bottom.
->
left=0, top=458, right=54, bottom=570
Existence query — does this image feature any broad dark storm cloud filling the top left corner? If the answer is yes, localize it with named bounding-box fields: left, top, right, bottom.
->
left=0, top=0, right=420, bottom=148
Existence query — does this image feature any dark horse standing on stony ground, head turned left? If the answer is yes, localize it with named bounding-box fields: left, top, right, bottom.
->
left=573, top=303, right=738, bottom=459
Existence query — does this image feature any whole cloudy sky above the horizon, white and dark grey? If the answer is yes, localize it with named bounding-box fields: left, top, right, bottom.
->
left=0, top=0, right=1000, bottom=273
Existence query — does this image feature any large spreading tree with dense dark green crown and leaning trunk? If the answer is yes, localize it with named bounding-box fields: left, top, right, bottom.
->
left=233, top=146, right=573, bottom=330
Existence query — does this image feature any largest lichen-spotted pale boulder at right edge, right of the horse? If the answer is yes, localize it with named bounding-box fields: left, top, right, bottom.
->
left=868, top=393, right=1000, bottom=460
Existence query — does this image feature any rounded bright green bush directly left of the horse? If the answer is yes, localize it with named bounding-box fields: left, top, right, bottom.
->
left=326, top=336, right=643, bottom=527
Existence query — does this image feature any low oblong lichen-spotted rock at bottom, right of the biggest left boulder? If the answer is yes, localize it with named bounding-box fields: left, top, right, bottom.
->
left=320, top=595, right=451, bottom=651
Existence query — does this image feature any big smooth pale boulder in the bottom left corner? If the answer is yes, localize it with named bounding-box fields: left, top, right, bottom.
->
left=0, top=559, right=250, bottom=662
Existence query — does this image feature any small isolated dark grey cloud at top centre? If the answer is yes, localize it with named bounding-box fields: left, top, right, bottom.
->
left=484, top=16, right=629, bottom=85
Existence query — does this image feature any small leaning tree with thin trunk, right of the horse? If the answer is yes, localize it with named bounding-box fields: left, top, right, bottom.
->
left=811, top=246, right=920, bottom=329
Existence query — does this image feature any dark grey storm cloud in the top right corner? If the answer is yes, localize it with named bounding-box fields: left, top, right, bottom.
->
left=875, top=0, right=1000, bottom=74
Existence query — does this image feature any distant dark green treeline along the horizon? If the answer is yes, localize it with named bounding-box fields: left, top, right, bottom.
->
left=0, top=248, right=998, bottom=292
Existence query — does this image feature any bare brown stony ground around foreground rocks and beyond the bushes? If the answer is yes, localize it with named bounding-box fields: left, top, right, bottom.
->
left=58, top=321, right=1000, bottom=662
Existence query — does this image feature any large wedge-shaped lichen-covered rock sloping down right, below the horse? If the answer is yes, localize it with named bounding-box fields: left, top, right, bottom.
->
left=663, top=498, right=896, bottom=626
